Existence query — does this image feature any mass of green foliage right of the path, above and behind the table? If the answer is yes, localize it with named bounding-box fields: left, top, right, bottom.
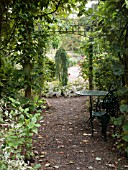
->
left=80, top=0, right=128, bottom=157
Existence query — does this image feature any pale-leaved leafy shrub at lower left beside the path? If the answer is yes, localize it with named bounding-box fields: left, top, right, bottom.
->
left=0, top=97, right=45, bottom=170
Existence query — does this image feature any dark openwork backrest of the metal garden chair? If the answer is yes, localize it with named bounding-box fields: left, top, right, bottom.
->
left=102, top=89, right=119, bottom=117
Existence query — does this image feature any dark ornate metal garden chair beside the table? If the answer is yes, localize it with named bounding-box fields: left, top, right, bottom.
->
left=92, top=90, right=119, bottom=141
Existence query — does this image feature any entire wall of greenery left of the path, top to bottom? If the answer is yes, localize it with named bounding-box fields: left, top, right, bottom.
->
left=0, top=0, right=85, bottom=169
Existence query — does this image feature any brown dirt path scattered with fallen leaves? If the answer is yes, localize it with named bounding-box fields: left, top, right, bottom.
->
left=35, top=96, right=128, bottom=170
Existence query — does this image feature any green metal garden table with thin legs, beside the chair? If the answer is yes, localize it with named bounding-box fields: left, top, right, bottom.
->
left=76, top=90, right=108, bottom=136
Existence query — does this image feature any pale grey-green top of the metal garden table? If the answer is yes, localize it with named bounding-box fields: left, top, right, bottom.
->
left=76, top=90, right=108, bottom=96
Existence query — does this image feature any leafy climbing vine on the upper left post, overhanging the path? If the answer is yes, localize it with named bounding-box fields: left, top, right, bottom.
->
left=0, top=0, right=85, bottom=98
